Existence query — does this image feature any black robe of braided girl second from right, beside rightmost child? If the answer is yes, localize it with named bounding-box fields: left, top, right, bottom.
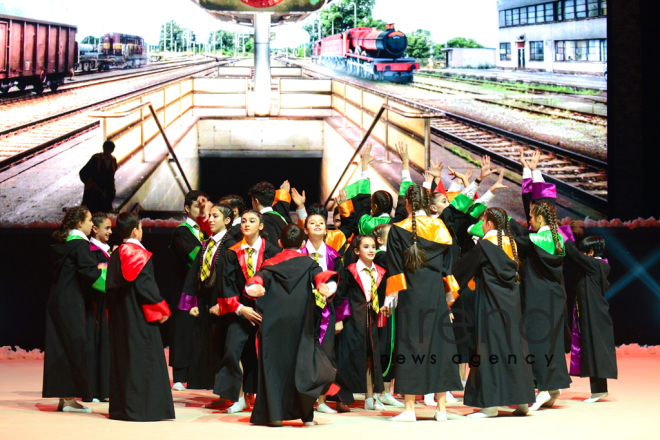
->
left=509, top=219, right=572, bottom=391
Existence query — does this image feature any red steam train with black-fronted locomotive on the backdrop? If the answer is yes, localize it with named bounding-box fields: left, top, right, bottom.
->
left=312, top=24, right=419, bottom=83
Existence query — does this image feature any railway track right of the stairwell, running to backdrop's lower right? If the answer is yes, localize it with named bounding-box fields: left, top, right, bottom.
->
left=282, top=58, right=607, bottom=212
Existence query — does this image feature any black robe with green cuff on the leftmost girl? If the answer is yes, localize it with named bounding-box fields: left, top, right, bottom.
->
left=42, top=235, right=106, bottom=398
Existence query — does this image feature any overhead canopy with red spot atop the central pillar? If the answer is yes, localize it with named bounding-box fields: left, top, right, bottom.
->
left=192, top=0, right=332, bottom=26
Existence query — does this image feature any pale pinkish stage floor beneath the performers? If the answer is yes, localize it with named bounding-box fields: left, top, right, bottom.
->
left=0, top=355, right=660, bottom=440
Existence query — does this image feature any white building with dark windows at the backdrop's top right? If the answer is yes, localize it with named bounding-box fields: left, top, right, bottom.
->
left=497, top=0, right=607, bottom=75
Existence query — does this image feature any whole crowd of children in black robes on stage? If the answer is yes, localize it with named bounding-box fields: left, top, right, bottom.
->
left=43, top=146, right=617, bottom=426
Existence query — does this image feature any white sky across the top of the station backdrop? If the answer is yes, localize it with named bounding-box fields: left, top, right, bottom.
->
left=0, top=0, right=497, bottom=48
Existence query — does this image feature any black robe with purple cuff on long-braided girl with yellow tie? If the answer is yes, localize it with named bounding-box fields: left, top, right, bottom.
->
left=179, top=232, right=236, bottom=390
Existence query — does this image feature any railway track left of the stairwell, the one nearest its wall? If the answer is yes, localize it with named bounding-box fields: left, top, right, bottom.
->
left=0, top=60, right=227, bottom=172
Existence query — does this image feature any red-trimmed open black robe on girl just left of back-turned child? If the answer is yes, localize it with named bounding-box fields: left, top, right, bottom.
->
left=213, top=239, right=282, bottom=402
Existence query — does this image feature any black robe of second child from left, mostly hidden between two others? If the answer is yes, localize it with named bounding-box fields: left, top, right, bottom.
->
left=83, top=243, right=110, bottom=402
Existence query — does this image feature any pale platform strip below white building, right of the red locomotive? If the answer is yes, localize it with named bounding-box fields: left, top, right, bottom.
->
left=428, top=68, right=607, bottom=91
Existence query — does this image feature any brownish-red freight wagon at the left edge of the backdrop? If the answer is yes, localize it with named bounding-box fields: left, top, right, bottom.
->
left=0, top=15, right=78, bottom=93
